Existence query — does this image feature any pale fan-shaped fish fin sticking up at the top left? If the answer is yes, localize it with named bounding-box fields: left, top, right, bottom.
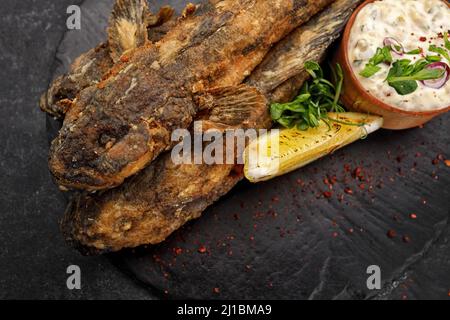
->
left=108, top=0, right=151, bottom=62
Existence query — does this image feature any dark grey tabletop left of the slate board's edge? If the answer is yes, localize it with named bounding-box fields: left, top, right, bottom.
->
left=0, top=0, right=152, bottom=299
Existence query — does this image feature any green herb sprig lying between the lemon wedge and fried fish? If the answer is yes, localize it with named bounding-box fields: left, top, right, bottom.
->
left=270, top=61, right=345, bottom=130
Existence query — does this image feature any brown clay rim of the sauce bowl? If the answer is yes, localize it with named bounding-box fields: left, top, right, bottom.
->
left=341, top=0, right=450, bottom=116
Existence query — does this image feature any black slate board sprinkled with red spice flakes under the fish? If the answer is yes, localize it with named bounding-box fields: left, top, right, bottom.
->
left=48, top=0, right=450, bottom=299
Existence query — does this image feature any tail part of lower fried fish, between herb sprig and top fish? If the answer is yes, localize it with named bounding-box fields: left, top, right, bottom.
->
left=247, top=0, right=362, bottom=102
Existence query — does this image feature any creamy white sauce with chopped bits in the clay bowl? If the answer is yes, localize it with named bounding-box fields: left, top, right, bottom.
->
left=348, top=0, right=450, bottom=111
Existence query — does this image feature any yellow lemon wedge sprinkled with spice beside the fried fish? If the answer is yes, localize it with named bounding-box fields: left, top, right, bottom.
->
left=244, top=112, right=383, bottom=182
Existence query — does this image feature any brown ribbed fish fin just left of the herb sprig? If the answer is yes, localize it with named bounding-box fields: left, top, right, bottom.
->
left=196, top=85, right=268, bottom=131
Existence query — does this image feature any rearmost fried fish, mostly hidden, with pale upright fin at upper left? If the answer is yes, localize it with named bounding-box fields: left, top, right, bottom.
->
left=39, top=0, right=176, bottom=118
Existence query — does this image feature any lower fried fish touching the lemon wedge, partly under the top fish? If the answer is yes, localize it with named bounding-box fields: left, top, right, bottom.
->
left=61, top=0, right=359, bottom=254
